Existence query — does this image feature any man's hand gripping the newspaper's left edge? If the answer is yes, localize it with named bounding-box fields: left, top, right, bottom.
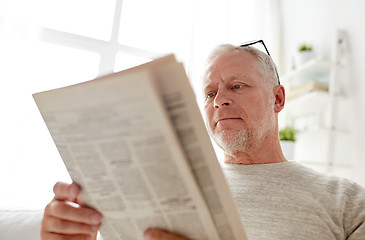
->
left=41, top=182, right=102, bottom=240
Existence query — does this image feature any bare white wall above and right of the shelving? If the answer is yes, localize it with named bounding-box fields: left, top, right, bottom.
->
left=281, top=0, right=365, bottom=185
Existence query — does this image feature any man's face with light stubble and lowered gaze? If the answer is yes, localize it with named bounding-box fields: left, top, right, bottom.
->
left=203, top=51, right=276, bottom=155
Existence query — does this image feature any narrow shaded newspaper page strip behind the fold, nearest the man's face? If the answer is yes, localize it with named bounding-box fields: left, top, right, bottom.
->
left=122, top=56, right=247, bottom=240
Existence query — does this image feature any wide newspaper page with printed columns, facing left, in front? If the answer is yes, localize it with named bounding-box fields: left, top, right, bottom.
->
left=34, top=63, right=219, bottom=240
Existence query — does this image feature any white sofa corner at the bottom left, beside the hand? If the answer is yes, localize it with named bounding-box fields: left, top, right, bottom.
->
left=0, top=210, right=43, bottom=240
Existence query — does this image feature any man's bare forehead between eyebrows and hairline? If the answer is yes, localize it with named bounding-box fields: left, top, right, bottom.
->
left=203, top=50, right=258, bottom=86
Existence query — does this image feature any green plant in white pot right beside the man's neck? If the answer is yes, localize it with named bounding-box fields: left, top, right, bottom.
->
left=279, top=126, right=297, bottom=160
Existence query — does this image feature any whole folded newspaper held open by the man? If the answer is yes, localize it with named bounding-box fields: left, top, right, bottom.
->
left=33, top=55, right=246, bottom=240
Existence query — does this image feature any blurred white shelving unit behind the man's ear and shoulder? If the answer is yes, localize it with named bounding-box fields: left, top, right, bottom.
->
left=281, top=32, right=353, bottom=173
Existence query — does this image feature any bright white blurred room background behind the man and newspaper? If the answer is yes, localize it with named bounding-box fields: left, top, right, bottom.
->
left=0, top=0, right=365, bottom=209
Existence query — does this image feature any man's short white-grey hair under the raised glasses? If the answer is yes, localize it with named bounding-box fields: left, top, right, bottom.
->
left=206, top=44, right=279, bottom=89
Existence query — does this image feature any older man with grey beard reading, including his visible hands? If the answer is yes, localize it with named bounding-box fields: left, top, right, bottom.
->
left=41, top=41, right=365, bottom=240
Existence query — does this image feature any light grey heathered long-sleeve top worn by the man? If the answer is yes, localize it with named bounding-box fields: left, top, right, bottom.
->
left=221, top=162, right=365, bottom=240
